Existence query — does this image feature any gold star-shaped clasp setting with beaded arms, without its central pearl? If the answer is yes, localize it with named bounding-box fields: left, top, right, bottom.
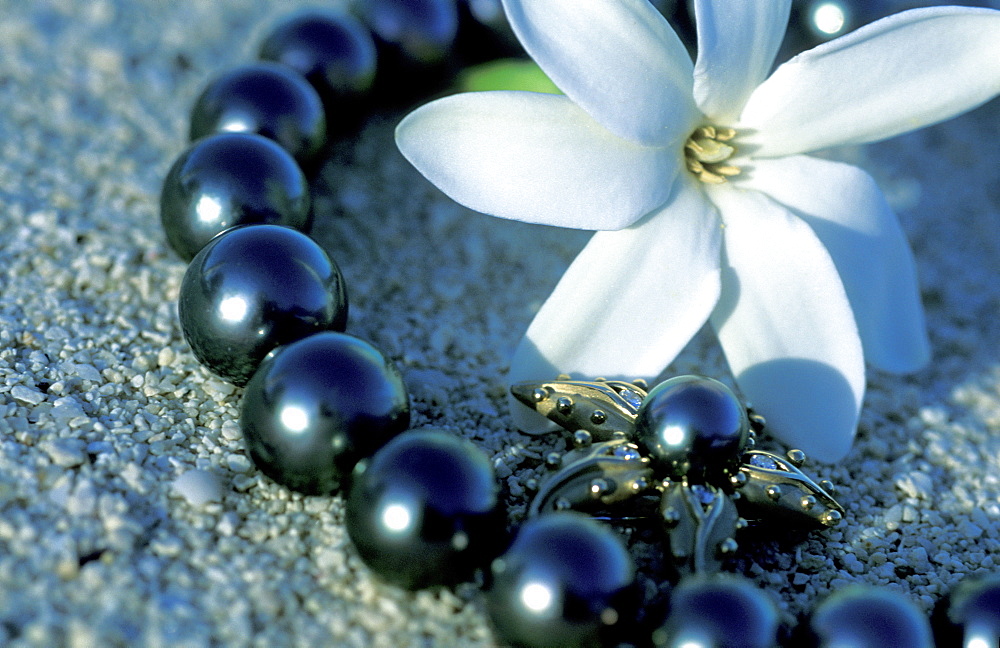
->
left=510, top=375, right=844, bottom=572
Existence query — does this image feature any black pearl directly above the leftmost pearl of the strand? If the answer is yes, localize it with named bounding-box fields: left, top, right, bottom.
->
left=191, top=61, right=326, bottom=163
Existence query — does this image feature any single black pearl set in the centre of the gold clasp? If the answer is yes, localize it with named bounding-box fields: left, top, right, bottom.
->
left=635, top=376, right=750, bottom=482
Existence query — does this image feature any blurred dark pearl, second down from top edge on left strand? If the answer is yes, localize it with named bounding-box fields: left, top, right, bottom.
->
left=260, top=9, right=376, bottom=99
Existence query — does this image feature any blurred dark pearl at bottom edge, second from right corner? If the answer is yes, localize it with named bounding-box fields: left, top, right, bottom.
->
left=809, top=585, right=934, bottom=648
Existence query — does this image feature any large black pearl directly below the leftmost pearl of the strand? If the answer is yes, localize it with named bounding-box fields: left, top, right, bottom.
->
left=178, top=225, right=347, bottom=385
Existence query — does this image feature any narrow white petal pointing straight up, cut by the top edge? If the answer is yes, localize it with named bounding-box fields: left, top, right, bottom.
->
left=694, top=0, right=792, bottom=125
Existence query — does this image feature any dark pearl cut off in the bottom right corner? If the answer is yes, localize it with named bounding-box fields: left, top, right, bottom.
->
left=931, top=574, right=1000, bottom=648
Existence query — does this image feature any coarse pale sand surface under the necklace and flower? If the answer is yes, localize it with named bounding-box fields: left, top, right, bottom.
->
left=0, top=0, right=1000, bottom=648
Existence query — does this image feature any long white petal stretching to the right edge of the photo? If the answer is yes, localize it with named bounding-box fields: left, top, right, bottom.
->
left=737, top=7, right=1000, bottom=157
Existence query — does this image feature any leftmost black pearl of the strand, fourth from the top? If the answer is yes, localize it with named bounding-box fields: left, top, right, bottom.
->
left=160, top=133, right=312, bottom=261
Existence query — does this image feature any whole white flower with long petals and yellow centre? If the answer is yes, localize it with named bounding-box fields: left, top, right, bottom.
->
left=396, top=0, right=1000, bottom=461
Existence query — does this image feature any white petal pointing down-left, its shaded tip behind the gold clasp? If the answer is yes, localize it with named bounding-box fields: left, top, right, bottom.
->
left=510, top=179, right=722, bottom=431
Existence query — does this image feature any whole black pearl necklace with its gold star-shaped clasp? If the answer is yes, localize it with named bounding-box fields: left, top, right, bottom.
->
left=161, top=0, right=1000, bottom=648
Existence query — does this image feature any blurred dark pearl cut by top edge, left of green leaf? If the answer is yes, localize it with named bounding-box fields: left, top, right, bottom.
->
left=362, top=0, right=458, bottom=65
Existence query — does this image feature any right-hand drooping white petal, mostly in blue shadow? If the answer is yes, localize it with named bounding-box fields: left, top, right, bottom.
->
left=746, top=155, right=930, bottom=372
